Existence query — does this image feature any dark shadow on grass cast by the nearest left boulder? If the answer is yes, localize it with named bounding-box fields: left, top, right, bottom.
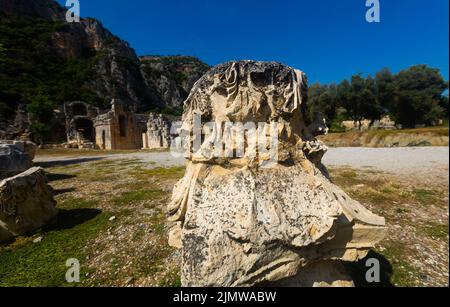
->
left=42, top=208, right=102, bottom=232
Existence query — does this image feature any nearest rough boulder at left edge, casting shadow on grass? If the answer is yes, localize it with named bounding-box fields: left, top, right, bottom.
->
left=0, top=167, right=58, bottom=242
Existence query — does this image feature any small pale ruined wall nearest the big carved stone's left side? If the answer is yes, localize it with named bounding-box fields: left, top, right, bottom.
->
left=142, top=113, right=173, bottom=149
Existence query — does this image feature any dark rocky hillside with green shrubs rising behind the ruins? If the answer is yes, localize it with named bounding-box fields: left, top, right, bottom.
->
left=0, top=0, right=208, bottom=129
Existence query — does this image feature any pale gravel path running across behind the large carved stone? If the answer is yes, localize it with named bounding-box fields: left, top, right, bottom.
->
left=35, top=147, right=449, bottom=185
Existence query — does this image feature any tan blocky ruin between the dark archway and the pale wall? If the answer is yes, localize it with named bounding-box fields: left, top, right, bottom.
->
left=94, top=99, right=147, bottom=150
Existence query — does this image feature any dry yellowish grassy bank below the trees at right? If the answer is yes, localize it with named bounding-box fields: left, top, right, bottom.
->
left=320, top=127, right=449, bottom=147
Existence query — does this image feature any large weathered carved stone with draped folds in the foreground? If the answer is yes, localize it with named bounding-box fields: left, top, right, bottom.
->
left=168, top=61, right=387, bottom=286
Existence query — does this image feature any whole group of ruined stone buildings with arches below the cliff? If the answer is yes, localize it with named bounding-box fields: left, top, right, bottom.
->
left=62, top=99, right=175, bottom=150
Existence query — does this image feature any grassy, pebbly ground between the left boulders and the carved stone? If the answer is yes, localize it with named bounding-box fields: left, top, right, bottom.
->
left=0, top=160, right=184, bottom=286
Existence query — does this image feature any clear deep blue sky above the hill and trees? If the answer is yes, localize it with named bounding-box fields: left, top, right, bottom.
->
left=59, top=0, right=449, bottom=83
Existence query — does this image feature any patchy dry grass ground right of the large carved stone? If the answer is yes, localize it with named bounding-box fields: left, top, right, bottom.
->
left=331, top=168, right=449, bottom=286
